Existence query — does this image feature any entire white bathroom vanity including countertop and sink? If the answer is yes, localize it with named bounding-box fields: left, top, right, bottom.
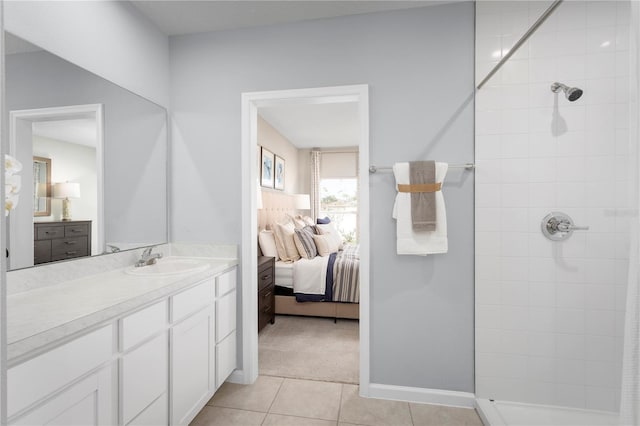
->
left=7, top=250, right=237, bottom=425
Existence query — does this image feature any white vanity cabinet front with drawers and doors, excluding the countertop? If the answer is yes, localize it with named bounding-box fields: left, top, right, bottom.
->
left=7, top=267, right=236, bottom=426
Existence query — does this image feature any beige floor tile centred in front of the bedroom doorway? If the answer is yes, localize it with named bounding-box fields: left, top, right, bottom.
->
left=269, top=379, right=342, bottom=421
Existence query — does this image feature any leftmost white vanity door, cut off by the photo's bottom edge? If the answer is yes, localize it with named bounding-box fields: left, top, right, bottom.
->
left=9, top=367, right=115, bottom=426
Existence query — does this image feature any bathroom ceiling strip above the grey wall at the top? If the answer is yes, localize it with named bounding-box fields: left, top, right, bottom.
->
left=131, top=0, right=450, bottom=35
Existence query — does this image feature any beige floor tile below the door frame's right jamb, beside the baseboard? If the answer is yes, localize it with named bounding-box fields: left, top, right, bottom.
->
left=340, top=385, right=412, bottom=426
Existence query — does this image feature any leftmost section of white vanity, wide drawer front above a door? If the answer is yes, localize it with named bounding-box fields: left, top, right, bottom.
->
left=7, top=325, right=116, bottom=425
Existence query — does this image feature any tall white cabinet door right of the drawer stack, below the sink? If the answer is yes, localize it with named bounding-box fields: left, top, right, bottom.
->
left=171, top=307, right=215, bottom=425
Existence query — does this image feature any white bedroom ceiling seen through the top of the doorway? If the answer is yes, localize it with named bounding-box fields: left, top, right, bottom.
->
left=258, top=102, right=359, bottom=148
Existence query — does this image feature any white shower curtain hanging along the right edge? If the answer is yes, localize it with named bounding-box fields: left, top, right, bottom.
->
left=620, top=1, right=640, bottom=425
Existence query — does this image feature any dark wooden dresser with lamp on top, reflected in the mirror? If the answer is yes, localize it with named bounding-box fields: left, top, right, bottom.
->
left=33, top=220, right=91, bottom=265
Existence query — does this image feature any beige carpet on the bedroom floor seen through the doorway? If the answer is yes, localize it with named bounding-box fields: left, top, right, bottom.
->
left=258, top=315, right=360, bottom=384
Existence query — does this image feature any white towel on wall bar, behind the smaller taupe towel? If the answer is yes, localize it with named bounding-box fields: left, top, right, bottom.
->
left=393, top=163, right=449, bottom=256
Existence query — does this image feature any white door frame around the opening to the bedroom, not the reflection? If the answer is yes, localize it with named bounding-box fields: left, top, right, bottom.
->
left=239, top=84, right=370, bottom=396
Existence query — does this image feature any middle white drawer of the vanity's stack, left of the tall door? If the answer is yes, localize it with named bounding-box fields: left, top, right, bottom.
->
left=120, top=333, right=169, bottom=424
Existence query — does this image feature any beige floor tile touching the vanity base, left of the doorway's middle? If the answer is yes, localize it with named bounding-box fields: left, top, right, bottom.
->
left=207, top=376, right=284, bottom=413
